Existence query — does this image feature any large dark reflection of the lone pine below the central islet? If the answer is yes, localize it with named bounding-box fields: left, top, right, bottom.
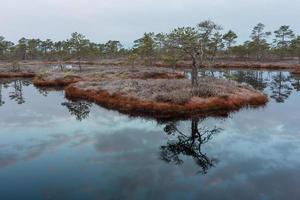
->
left=160, top=119, right=220, bottom=174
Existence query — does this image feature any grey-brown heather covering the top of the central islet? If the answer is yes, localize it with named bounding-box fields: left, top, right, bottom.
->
left=70, top=78, right=260, bottom=105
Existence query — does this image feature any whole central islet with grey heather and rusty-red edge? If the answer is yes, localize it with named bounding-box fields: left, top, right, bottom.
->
left=65, top=78, right=267, bottom=118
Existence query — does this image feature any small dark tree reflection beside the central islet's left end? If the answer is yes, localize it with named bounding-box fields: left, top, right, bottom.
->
left=61, top=101, right=92, bottom=121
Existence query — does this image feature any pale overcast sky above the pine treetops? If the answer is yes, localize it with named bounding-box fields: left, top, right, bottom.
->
left=0, top=0, right=300, bottom=46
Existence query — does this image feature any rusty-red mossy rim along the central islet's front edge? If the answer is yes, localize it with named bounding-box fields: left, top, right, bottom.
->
left=65, top=81, right=268, bottom=118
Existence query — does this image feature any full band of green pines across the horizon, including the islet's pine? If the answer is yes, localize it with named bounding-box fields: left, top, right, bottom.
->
left=0, top=20, right=300, bottom=80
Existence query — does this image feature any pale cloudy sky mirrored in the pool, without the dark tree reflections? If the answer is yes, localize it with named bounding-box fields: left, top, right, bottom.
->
left=0, top=76, right=300, bottom=200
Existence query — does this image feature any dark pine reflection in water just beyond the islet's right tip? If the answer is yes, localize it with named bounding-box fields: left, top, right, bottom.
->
left=270, top=72, right=293, bottom=103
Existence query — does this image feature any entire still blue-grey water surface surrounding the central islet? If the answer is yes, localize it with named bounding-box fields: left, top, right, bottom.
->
left=0, top=71, right=300, bottom=200
